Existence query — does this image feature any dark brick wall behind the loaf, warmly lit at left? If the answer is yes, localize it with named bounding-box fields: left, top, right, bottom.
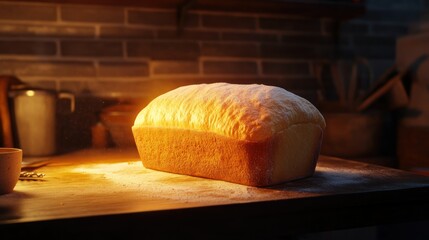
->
left=0, top=0, right=427, bottom=150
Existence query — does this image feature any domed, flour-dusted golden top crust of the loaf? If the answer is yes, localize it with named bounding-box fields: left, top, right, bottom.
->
left=134, top=83, right=325, bottom=142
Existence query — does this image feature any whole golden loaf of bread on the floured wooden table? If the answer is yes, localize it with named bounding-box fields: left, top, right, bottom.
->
left=132, top=83, right=325, bottom=186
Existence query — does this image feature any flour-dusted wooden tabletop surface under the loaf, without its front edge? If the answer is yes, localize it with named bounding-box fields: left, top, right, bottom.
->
left=0, top=147, right=429, bottom=223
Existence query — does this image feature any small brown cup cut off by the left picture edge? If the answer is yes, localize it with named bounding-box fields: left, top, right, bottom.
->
left=0, top=148, right=22, bottom=194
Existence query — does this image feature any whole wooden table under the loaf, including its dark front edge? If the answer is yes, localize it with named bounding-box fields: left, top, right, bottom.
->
left=0, top=150, right=429, bottom=239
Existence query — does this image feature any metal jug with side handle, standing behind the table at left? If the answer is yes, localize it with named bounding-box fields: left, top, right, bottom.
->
left=9, top=89, right=74, bottom=156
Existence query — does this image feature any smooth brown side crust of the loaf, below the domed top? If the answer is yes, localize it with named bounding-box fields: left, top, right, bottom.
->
left=132, top=124, right=322, bottom=186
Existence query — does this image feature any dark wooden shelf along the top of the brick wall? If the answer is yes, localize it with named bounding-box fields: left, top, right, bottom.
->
left=10, top=0, right=365, bottom=20
